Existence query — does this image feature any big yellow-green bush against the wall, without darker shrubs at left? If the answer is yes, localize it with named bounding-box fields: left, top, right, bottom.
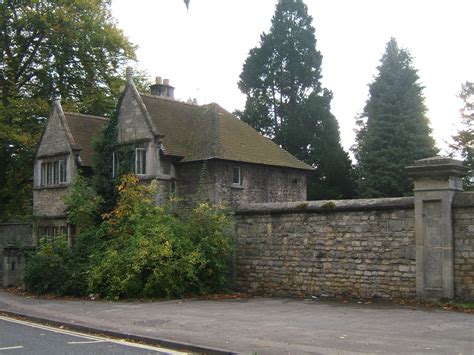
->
left=89, top=175, right=231, bottom=298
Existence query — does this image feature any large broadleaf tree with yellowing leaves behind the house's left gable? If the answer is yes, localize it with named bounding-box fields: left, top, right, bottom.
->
left=0, top=0, right=135, bottom=218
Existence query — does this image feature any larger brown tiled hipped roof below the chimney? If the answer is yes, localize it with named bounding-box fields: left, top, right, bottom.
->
left=140, top=94, right=312, bottom=170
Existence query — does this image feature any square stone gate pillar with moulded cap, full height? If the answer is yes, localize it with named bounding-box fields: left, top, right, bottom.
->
left=406, top=157, right=467, bottom=298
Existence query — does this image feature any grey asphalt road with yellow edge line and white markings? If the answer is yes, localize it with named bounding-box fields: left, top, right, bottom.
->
left=0, top=316, right=183, bottom=354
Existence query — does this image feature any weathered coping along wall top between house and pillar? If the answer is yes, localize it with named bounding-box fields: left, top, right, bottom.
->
left=235, top=197, right=415, bottom=214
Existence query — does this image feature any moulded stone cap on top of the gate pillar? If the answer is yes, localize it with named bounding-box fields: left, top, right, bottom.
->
left=405, top=156, right=469, bottom=177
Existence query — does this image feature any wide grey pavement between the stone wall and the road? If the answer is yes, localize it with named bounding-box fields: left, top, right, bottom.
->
left=0, top=290, right=474, bottom=355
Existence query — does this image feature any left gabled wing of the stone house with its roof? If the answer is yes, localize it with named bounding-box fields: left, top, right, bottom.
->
left=33, top=100, right=107, bottom=242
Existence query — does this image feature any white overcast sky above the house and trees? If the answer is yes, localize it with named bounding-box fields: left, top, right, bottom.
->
left=112, top=0, right=474, bottom=154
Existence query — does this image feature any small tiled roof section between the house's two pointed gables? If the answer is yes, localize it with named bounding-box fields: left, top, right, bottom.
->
left=64, top=112, right=107, bottom=166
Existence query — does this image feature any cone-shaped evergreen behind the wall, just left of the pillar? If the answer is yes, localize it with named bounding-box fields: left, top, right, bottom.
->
left=354, top=38, right=437, bottom=197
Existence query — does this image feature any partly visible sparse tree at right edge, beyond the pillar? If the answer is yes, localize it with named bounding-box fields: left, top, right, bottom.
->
left=450, top=81, right=474, bottom=190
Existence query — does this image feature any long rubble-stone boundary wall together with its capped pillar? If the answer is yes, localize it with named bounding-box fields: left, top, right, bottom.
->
left=233, top=157, right=474, bottom=300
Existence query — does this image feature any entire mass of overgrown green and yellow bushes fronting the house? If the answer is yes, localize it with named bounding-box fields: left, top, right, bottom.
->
left=24, top=175, right=231, bottom=299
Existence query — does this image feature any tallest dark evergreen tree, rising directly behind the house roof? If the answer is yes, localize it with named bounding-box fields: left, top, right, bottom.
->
left=237, top=0, right=353, bottom=199
